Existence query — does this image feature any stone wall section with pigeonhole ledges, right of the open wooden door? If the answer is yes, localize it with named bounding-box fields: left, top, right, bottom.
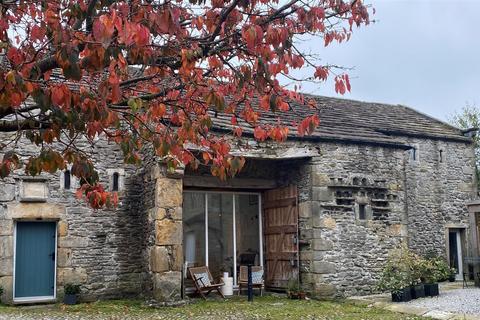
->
left=300, top=143, right=407, bottom=298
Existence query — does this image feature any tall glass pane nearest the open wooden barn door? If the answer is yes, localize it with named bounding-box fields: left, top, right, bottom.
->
left=235, top=194, right=260, bottom=265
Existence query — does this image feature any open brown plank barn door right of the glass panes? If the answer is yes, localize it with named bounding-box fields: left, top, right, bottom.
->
left=263, top=186, right=299, bottom=289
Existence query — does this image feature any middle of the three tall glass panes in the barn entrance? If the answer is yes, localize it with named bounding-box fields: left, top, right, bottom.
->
left=208, top=193, right=233, bottom=280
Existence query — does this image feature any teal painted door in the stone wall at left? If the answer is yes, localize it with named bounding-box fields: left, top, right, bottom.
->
left=15, top=222, right=56, bottom=298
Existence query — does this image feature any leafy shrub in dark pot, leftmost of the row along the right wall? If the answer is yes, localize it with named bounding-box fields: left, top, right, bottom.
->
left=378, top=246, right=413, bottom=302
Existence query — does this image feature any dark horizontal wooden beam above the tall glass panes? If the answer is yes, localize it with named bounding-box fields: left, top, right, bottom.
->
left=183, top=176, right=277, bottom=190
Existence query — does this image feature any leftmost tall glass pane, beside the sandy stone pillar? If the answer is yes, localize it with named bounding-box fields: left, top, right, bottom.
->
left=183, top=192, right=205, bottom=272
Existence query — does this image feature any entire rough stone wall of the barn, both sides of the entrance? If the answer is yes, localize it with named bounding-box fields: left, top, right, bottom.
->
left=0, top=131, right=476, bottom=301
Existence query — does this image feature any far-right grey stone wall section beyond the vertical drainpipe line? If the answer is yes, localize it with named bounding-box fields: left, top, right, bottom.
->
left=406, top=139, right=476, bottom=256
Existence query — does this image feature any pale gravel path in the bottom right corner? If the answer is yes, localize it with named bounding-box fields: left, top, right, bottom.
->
left=405, top=288, right=480, bottom=315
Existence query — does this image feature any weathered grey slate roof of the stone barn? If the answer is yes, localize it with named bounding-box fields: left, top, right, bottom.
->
left=212, top=95, right=471, bottom=147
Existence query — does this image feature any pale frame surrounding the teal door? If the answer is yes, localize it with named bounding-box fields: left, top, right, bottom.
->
left=12, top=220, right=58, bottom=303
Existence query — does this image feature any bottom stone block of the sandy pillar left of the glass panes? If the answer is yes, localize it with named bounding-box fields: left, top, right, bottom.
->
left=153, top=271, right=182, bottom=301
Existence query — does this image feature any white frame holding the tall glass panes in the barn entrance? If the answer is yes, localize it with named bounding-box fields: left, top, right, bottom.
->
left=182, top=189, right=264, bottom=289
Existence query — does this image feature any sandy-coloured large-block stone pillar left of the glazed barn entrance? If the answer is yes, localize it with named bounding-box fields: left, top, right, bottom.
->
left=143, top=158, right=183, bottom=302
